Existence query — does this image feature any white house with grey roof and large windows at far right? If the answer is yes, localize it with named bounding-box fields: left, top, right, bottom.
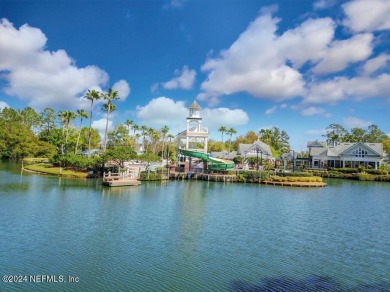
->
left=307, top=141, right=385, bottom=169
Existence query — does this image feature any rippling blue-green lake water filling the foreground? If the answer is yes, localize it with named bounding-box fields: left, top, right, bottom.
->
left=0, top=163, right=390, bottom=291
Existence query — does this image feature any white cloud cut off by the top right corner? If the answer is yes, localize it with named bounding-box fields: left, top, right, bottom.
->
left=342, top=0, right=390, bottom=32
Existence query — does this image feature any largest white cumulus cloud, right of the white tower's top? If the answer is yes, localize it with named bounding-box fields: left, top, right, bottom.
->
left=198, top=13, right=334, bottom=104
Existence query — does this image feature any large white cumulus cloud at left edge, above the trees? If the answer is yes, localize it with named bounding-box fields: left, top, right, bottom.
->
left=0, top=19, right=108, bottom=109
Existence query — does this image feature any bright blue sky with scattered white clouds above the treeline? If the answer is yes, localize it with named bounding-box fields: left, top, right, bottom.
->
left=0, top=0, right=390, bottom=151
